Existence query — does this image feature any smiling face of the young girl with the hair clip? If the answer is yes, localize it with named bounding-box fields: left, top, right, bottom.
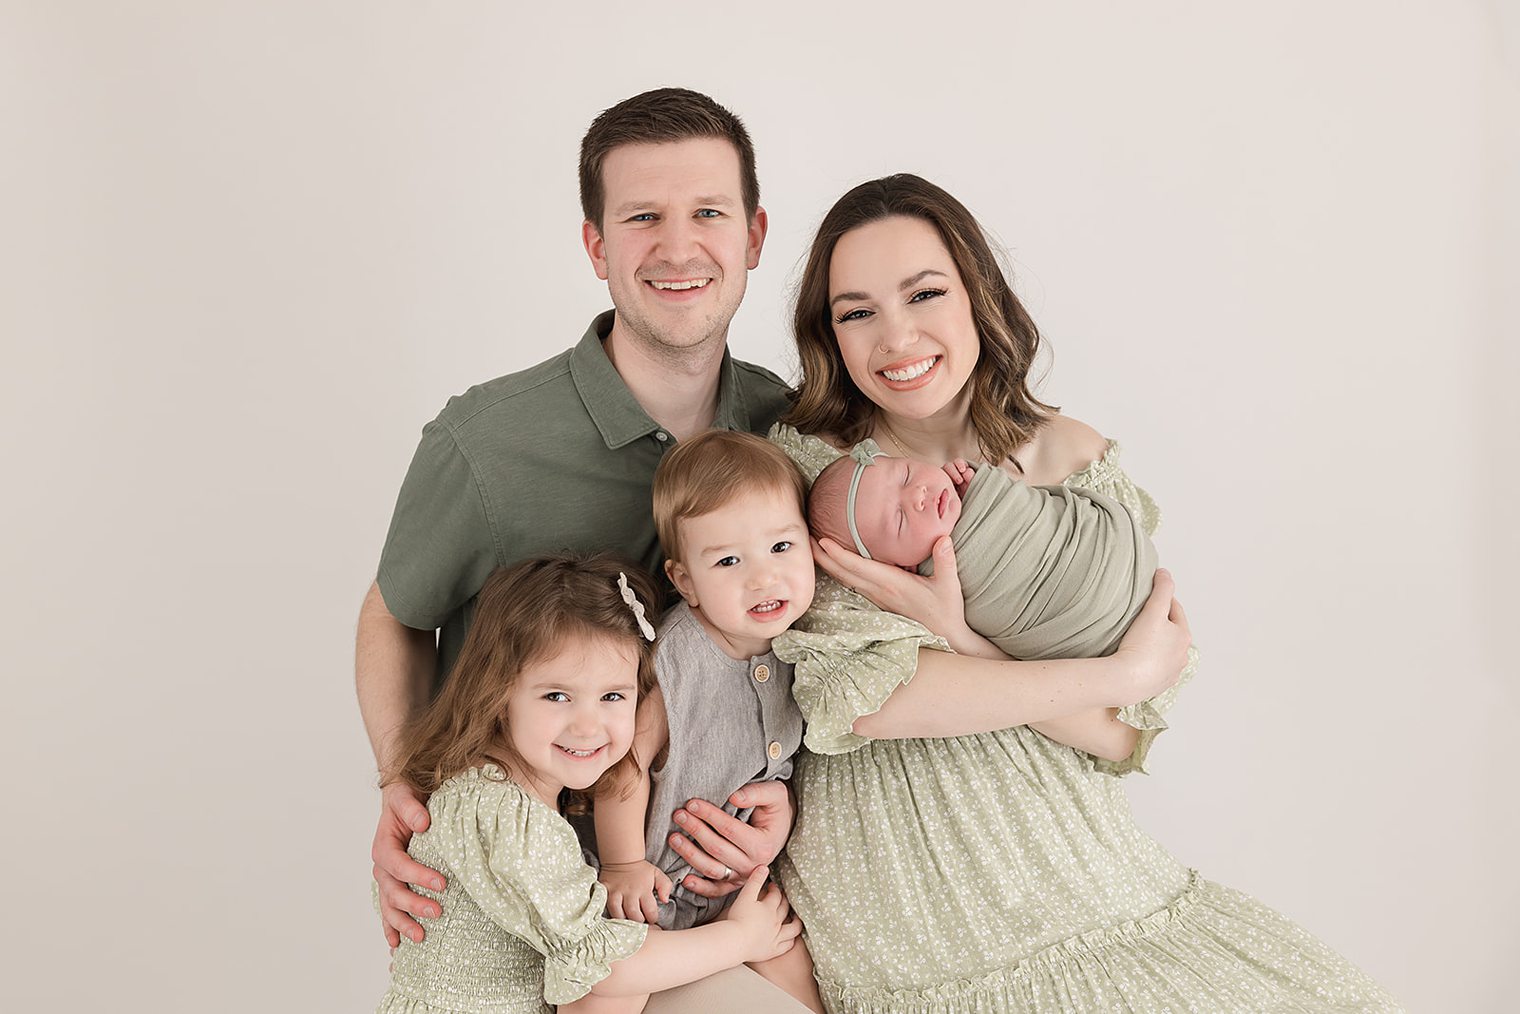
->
left=506, top=635, right=638, bottom=806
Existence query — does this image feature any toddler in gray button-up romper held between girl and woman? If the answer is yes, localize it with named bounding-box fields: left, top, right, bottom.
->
left=594, top=430, right=822, bottom=1011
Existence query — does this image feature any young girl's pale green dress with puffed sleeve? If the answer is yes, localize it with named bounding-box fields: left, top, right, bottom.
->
left=378, top=765, right=649, bottom=1014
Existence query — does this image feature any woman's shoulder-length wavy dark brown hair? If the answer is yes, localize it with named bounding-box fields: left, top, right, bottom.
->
left=781, top=173, right=1056, bottom=464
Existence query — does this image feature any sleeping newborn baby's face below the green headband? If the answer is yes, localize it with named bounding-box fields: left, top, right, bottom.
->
left=856, top=456, right=961, bottom=567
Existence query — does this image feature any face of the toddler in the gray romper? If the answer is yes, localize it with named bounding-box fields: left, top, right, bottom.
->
left=669, top=490, right=813, bottom=658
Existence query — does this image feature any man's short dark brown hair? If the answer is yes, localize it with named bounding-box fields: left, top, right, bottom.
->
left=581, top=88, right=760, bottom=231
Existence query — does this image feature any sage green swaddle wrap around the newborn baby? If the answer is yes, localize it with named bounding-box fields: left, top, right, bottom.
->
left=918, top=465, right=1157, bottom=660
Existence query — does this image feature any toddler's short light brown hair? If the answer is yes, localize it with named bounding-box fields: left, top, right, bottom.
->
left=654, top=430, right=807, bottom=561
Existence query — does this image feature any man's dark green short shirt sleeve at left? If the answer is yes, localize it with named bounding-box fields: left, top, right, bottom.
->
left=377, top=417, right=500, bottom=629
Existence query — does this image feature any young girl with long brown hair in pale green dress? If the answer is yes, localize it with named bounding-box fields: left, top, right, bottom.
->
left=378, top=555, right=800, bottom=1014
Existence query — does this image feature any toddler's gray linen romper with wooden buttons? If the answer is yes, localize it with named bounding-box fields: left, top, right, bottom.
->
left=644, top=602, right=803, bottom=929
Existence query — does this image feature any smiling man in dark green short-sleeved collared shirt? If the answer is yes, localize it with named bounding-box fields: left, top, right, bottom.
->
left=356, top=88, right=792, bottom=1009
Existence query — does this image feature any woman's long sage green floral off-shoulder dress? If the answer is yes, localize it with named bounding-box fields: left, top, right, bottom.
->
left=771, top=426, right=1400, bottom=1014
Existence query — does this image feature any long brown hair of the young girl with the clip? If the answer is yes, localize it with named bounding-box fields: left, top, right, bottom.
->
left=380, top=553, right=660, bottom=800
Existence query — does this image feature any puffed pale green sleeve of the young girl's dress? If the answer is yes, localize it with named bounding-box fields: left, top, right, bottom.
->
left=447, top=778, right=649, bottom=1005
